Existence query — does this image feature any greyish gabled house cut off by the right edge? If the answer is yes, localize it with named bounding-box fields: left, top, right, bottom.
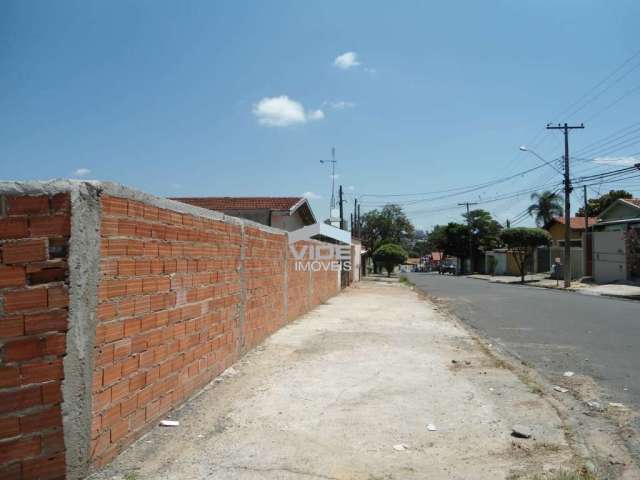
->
left=593, top=198, right=640, bottom=283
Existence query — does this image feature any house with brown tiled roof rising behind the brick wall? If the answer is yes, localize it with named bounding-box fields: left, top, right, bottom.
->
left=172, top=197, right=316, bottom=232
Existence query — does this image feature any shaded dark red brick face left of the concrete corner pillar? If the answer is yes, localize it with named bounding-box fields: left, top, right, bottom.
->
left=0, top=194, right=70, bottom=479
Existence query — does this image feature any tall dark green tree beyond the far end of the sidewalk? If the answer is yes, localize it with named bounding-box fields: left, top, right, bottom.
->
left=360, top=205, right=414, bottom=272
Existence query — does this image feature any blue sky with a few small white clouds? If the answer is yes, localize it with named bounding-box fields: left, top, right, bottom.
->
left=0, top=0, right=640, bottom=228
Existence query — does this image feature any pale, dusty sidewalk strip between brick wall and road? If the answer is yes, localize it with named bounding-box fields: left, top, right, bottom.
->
left=87, top=282, right=624, bottom=480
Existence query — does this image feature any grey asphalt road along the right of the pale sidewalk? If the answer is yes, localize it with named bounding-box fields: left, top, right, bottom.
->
left=409, top=273, right=640, bottom=408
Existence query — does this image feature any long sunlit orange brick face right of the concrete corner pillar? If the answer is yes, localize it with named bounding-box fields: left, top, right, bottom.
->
left=91, top=196, right=337, bottom=467
